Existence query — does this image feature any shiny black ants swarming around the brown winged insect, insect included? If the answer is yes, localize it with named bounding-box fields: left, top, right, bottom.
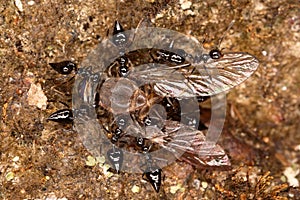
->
left=48, top=21, right=259, bottom=192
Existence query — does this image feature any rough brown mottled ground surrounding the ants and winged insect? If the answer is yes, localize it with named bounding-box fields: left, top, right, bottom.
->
left=0, top=0, right=300, bottom=199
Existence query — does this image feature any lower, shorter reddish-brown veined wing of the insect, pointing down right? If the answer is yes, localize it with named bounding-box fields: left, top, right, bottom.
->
left=148, top=120, right=231, bottom=167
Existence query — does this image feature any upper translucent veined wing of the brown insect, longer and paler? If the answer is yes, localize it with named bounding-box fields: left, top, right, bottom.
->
left=128, top=52, right=259, bottom=98
